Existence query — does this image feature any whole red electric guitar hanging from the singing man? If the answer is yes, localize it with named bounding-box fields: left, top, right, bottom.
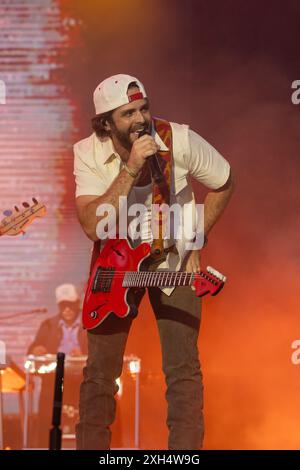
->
left=83, top=239, right=226, bottom=330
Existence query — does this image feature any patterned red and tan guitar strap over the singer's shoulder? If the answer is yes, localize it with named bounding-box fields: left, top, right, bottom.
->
left=151, top=118, right=173, bottom=260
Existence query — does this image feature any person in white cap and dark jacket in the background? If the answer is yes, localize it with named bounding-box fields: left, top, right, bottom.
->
left=27, top=284, right=87, bottom=447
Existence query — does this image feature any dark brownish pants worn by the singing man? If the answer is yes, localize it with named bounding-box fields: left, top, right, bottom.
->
left=76, top=280, right=204, bottom=450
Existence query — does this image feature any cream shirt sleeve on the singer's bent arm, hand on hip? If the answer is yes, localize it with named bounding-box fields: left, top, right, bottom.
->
left=186, top=129, right=230, bottom=189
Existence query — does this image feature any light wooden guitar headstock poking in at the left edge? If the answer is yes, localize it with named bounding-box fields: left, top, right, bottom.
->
left=0, top=197, right=46, bottom=236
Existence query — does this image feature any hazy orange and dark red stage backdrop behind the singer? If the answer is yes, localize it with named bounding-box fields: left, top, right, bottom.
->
left=0, top=0, right=300, bottom=449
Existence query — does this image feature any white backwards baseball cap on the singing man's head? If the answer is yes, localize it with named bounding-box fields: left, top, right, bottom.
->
left=93, top=73, right=147, bottom=114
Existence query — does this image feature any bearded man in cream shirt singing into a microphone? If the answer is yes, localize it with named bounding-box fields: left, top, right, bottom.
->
left=74, top=74, right=233, bottom=449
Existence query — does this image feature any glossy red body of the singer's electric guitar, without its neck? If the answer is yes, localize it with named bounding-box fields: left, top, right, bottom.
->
left=82, top=239, right=150, bottom=330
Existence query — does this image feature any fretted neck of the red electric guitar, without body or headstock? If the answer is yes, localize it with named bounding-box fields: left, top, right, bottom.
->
left=123, top=271, right=197, bottom=287
